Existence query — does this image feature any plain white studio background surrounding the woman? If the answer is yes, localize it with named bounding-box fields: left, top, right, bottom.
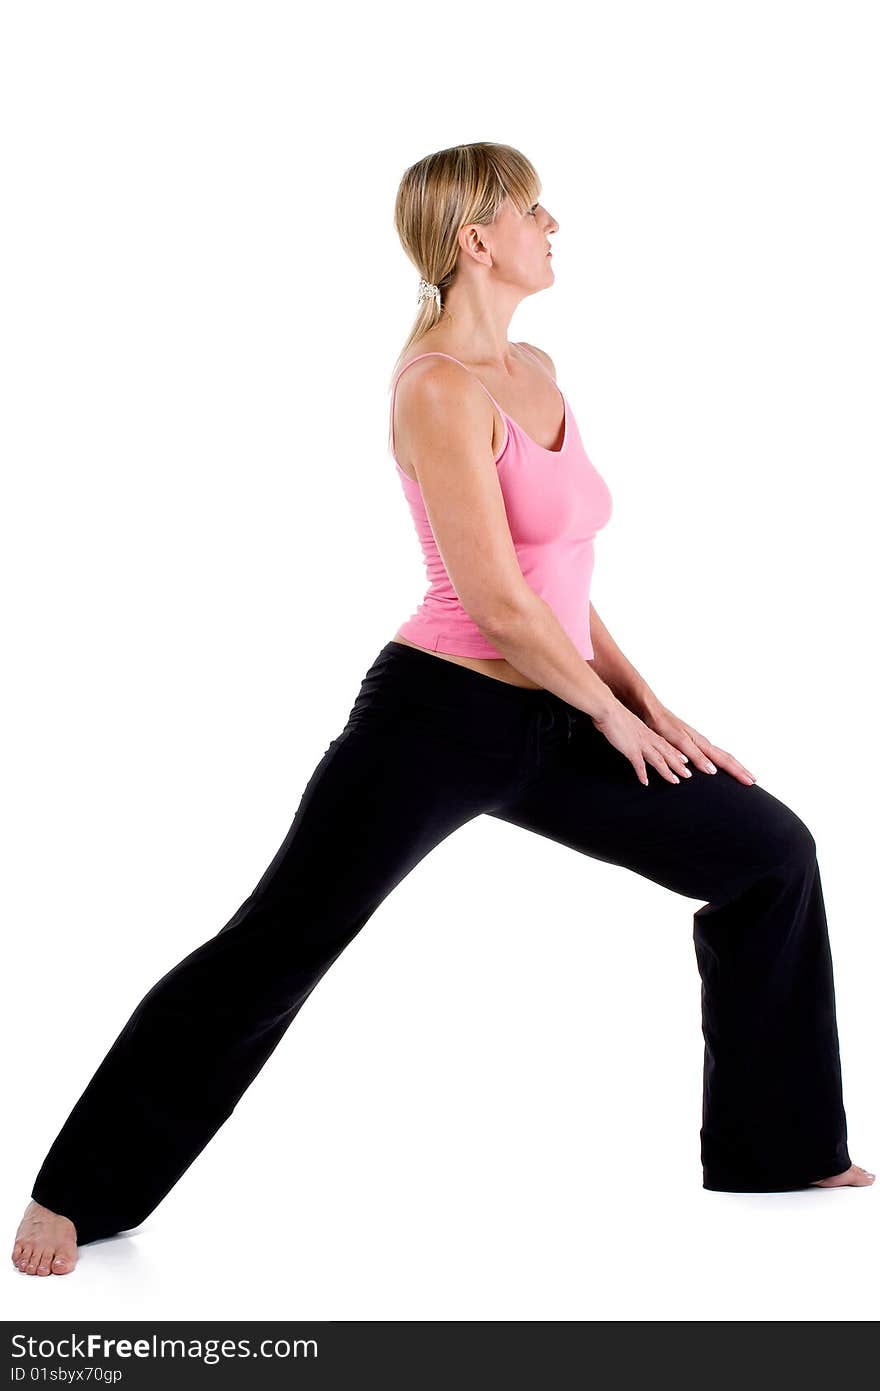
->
left=0, top=0, right=880, bottom=1320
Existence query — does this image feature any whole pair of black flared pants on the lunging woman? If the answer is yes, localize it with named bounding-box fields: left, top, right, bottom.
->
left=32, top=641, right=849, bottom=1242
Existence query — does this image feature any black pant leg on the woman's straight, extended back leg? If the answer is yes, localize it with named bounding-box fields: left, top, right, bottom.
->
left=32, top=667, right=516, bottom=1244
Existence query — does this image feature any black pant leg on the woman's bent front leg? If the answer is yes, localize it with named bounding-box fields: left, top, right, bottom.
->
left=489, top=707, right=851, bottom=1192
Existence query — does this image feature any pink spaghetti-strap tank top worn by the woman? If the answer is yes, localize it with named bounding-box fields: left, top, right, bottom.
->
left=391, top=344, right=612, bottom=658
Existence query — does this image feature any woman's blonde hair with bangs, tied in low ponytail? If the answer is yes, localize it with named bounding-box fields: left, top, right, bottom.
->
left=392, top=140, right=541, bottom=381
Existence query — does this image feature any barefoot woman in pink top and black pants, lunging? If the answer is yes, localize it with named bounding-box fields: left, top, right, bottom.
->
left=13, top=143, right=874, bottom=1274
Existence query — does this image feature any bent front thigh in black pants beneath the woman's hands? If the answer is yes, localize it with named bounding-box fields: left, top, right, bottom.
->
left=489, top=718, right=815, bottom=901
